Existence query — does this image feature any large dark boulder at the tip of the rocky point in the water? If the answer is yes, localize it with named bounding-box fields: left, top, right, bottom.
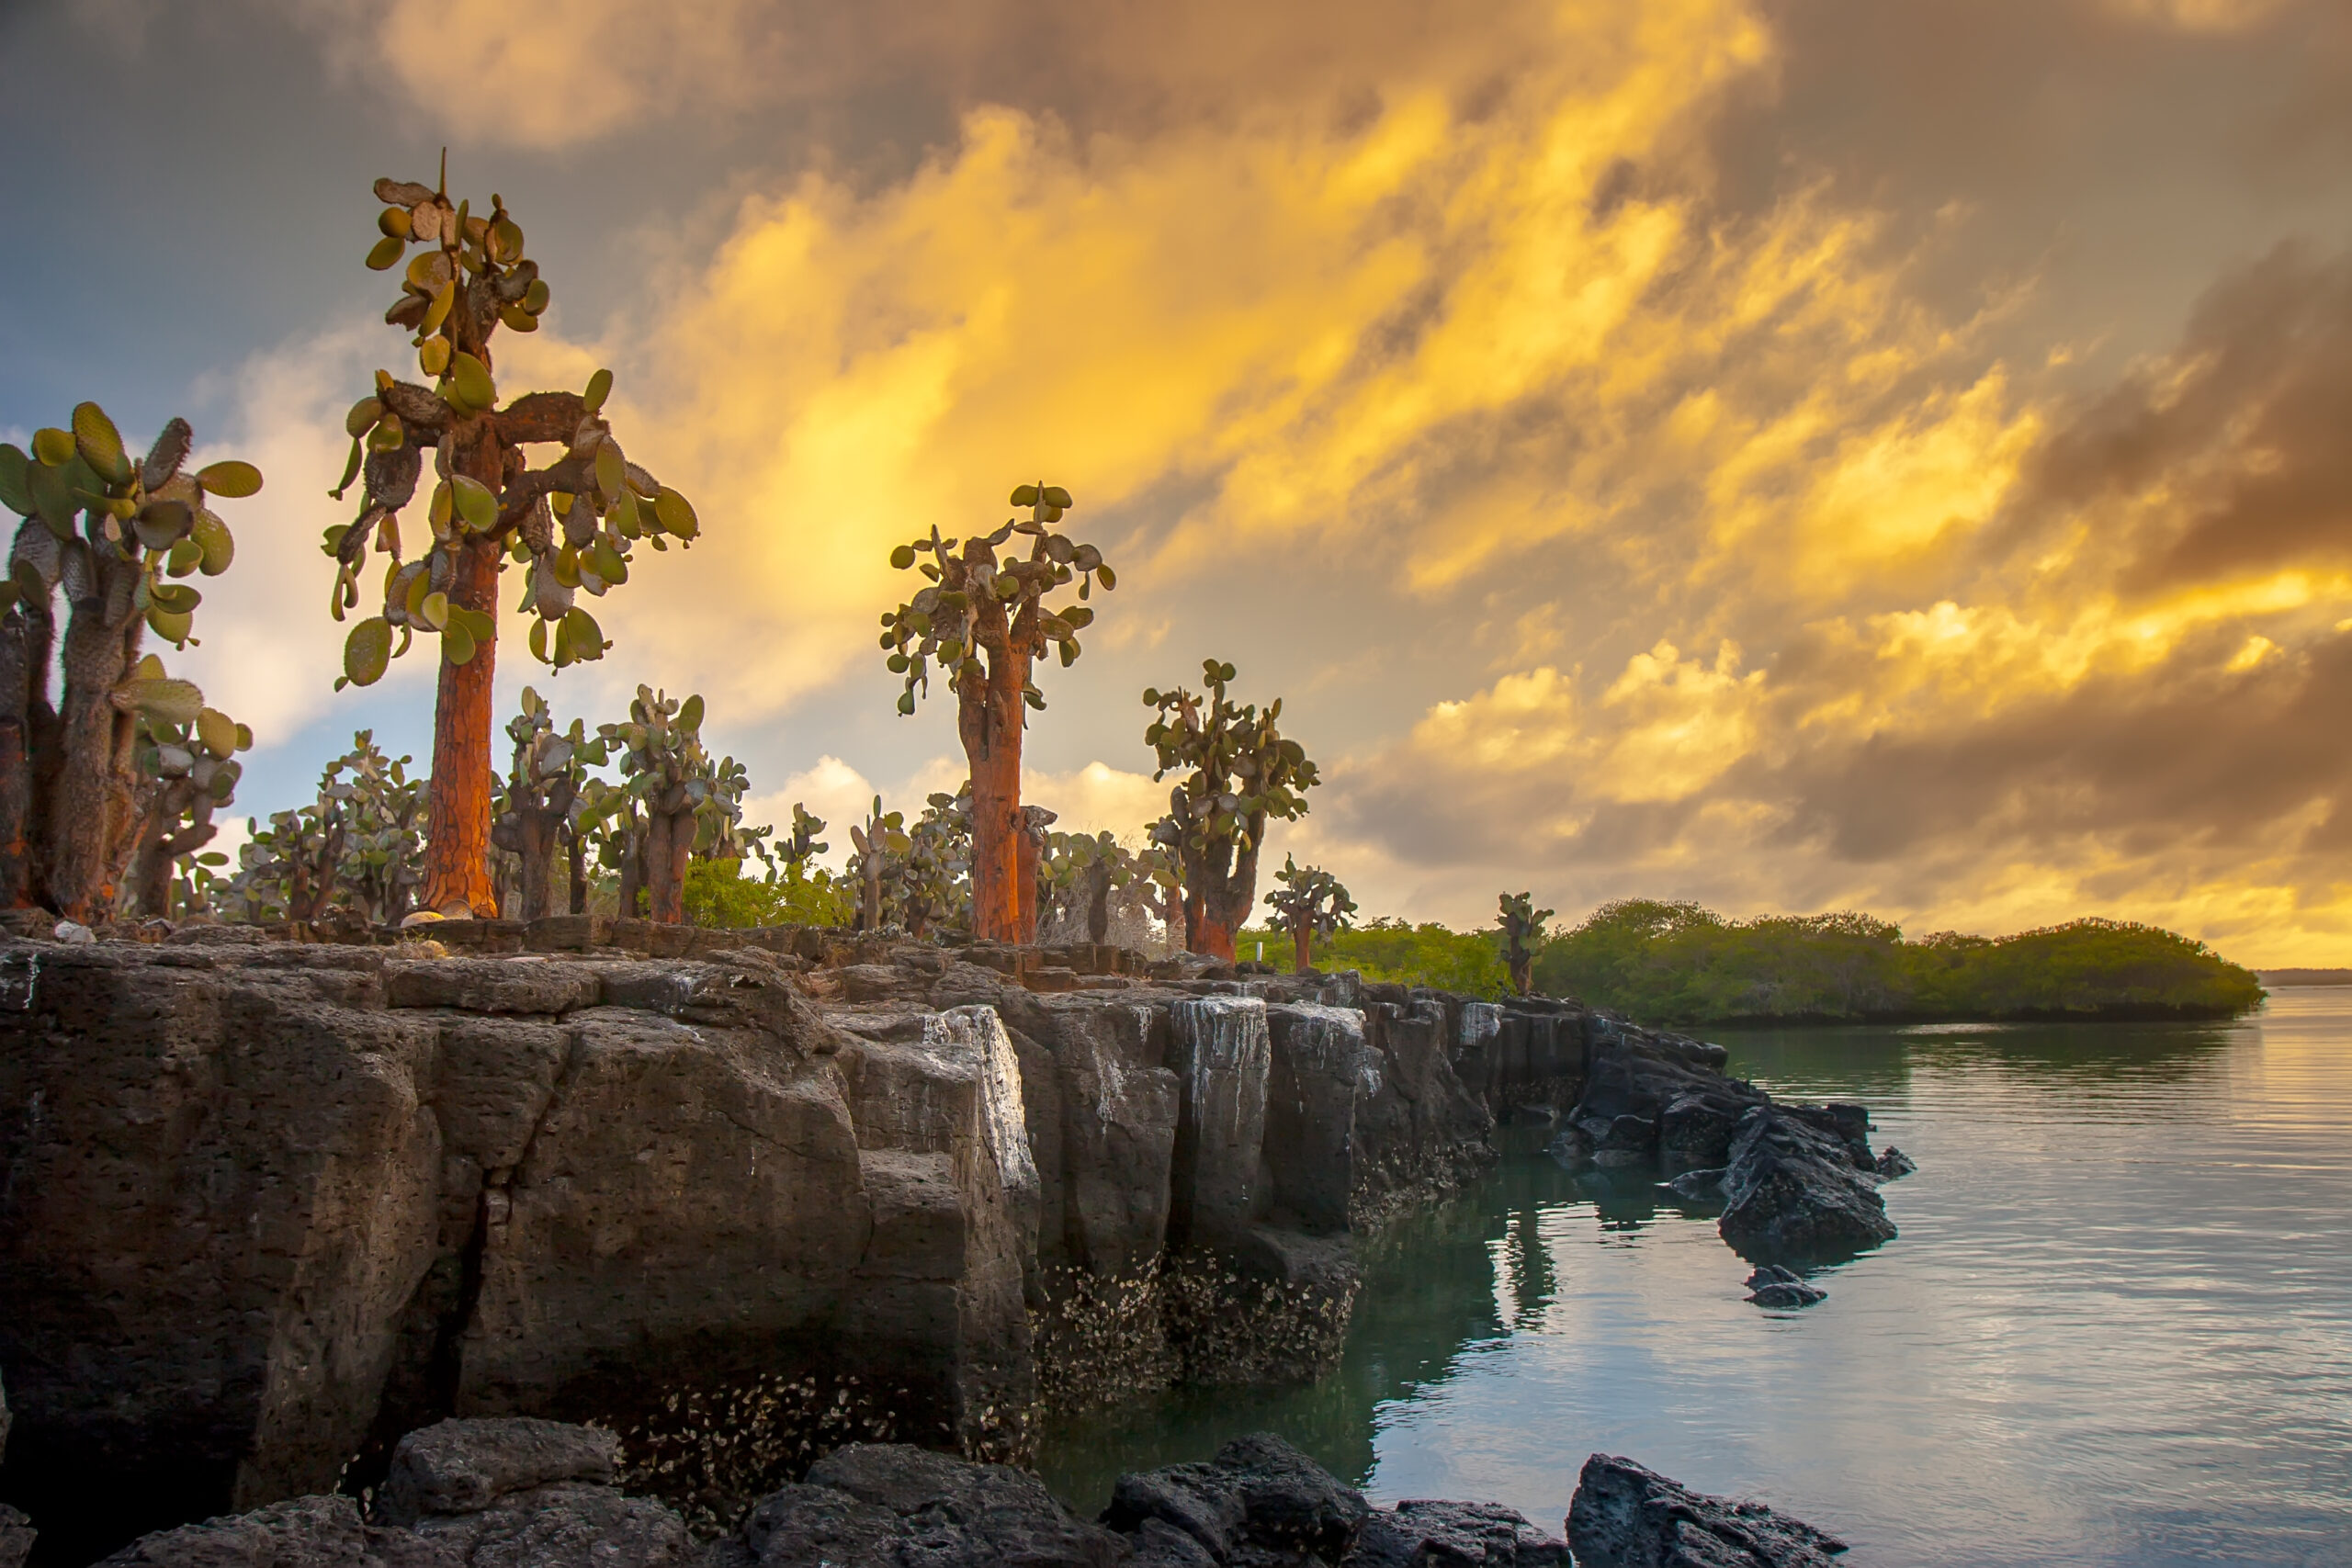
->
left=1717, top=1105, right=1895, bottom=1262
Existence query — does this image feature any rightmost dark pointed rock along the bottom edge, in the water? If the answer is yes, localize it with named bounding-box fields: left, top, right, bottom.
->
left=1569, top=1453, right=1847, bottom=1568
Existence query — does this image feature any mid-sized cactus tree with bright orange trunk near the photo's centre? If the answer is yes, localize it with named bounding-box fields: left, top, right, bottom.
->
left=882, top=484, right=1117, bottom=942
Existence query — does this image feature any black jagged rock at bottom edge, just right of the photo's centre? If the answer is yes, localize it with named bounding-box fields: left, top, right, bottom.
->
left=1103, top=1432, right=1371, bottom=1563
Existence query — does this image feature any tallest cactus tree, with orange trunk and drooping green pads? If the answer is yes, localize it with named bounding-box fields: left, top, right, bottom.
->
left=324, top=169, right=698, bottom=915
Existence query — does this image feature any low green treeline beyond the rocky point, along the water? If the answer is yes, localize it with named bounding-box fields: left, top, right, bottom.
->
left=1270, top=898, right=2263, bottom=1025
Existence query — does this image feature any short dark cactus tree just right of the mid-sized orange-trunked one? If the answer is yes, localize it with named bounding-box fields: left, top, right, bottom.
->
left=1143, top=659, right=1322, bottom=962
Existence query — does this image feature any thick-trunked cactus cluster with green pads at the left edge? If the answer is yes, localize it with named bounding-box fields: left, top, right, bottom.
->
left=0, top=402, right=261, bottom=921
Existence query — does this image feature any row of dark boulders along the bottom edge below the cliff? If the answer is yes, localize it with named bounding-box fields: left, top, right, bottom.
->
left=78, top=1420, right=1847, bottom=1568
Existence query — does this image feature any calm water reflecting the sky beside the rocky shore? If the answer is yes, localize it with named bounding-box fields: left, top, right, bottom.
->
left=1042, top=989, right=2352, bottom=1565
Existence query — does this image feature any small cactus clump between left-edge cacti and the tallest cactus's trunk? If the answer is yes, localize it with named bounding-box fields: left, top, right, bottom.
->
left=217, top=728, right=425, bottom=926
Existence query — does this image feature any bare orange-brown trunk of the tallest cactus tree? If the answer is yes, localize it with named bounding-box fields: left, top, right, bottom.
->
left=419, top=526, right=501, bottom=919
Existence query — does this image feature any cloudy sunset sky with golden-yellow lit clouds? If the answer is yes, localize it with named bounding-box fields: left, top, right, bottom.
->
left=0, top=0, right=2352, bottom=964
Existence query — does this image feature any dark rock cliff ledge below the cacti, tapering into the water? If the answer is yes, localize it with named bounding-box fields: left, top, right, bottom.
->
left=0, top=917, right=1900, bottom=1563
